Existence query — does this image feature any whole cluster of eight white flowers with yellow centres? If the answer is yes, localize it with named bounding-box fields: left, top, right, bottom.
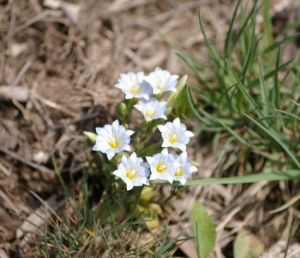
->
left=93, top=68, right=197, bottom=190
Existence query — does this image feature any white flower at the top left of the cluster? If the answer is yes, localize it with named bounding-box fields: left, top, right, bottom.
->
left=115, top=72, right=152, bottom=99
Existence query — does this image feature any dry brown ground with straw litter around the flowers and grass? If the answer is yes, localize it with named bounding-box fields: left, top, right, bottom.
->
left=0, top=0, right=300, bottom=258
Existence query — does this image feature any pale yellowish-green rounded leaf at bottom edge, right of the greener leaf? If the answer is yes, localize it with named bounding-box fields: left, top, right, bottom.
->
left=233, top=230, right=264, bottom=258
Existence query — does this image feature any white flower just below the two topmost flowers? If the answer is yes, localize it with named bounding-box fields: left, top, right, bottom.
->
left=134, top=98, right=167, bottom=121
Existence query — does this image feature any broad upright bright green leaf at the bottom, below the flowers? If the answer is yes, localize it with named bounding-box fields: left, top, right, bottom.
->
left=192, top=203, right=216, bottom=258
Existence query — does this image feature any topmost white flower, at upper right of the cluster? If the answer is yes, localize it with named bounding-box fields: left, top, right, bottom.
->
left=145, top=68, right=179, bottom=94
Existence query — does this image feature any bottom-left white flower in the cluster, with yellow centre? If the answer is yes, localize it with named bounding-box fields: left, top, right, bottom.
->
left=113, top=152, right=149, bottom=191
